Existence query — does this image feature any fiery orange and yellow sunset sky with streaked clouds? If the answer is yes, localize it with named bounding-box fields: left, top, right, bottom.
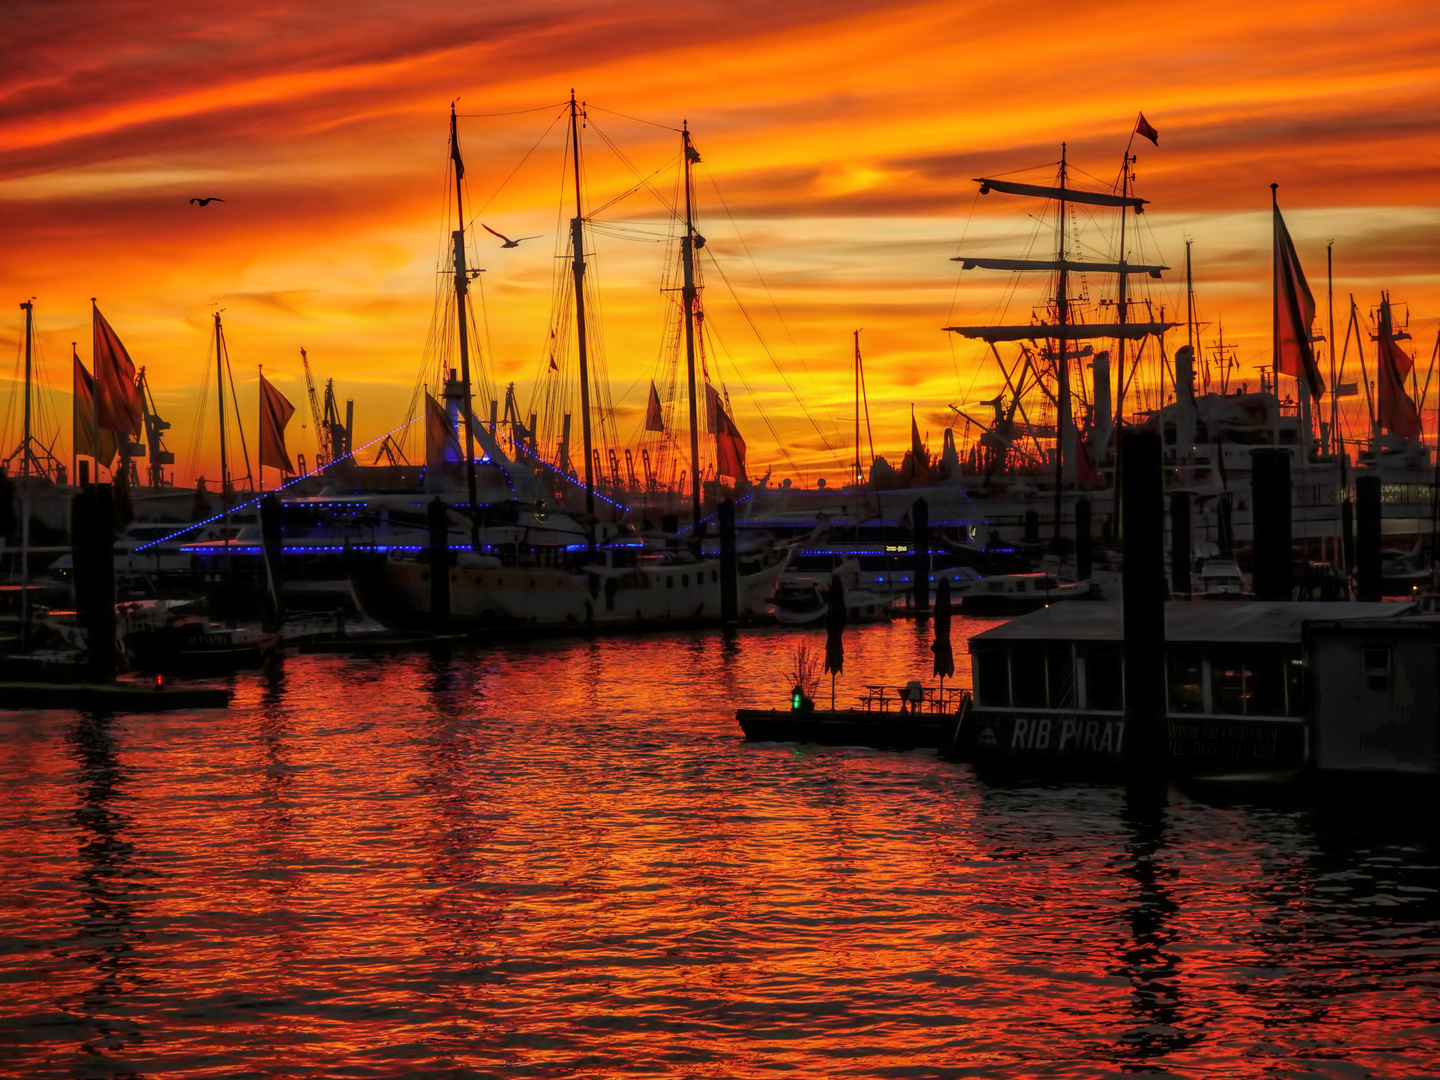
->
left=0, top=0, right=1440, bottom=482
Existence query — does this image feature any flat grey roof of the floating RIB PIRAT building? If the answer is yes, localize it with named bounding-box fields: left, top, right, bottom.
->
left=971, top=600, right=1416, bottom=645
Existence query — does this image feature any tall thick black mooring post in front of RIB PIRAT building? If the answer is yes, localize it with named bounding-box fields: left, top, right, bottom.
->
left=1120, top=428, right=1169, bottom=788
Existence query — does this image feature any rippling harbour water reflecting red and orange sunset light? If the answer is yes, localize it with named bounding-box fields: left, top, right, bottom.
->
left=0, top=621, right=1440, bottom=1077
